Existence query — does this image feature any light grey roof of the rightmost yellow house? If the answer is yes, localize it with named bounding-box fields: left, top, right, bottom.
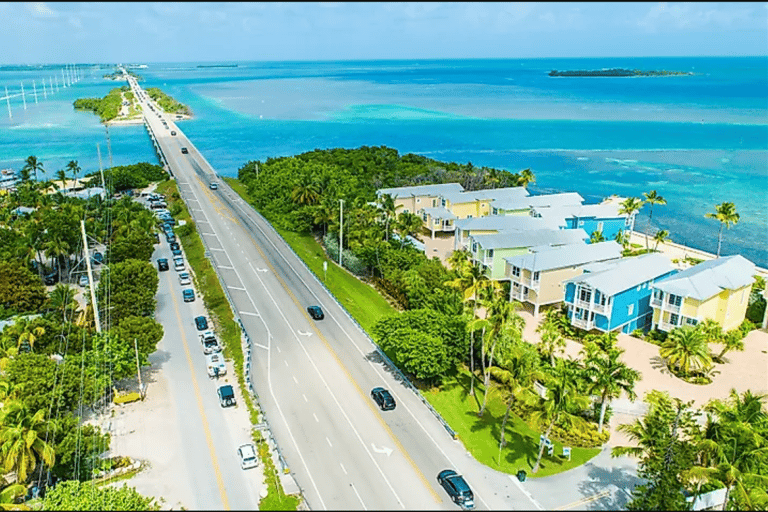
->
left=654, top=255, right=755, bottom=300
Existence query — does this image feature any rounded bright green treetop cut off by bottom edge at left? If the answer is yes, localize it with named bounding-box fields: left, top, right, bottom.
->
left=42, top=480, right=160, bottom=511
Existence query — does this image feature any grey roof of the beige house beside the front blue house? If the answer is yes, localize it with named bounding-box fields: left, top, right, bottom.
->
left=505, top=241, right=621, bottom=272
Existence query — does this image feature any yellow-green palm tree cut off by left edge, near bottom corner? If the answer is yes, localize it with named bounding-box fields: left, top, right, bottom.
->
left=0, top=400, right=55, bottom=483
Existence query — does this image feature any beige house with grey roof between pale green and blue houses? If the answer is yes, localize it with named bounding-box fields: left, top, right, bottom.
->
left=505, top=241, right=622, bottom=316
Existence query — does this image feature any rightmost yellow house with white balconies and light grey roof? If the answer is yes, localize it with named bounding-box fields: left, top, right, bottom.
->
left=651, top=255, right=755, bottom=332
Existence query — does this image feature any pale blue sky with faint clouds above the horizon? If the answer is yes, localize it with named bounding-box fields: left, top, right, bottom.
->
left=0, top=2, right=768, bottom=64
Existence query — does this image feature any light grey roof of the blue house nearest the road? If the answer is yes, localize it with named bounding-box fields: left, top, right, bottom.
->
left=563, top=252, right=675, bottom=295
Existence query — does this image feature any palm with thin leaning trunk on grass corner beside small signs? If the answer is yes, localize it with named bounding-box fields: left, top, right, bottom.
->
left=531, top=359, right=589, bottom=473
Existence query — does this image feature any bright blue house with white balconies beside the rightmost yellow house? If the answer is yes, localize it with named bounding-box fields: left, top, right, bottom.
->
left=563, top=253, right=677, bottom=334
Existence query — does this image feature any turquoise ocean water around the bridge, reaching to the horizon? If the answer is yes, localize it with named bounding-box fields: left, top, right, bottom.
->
left=0, top=57, right=768, bottom=267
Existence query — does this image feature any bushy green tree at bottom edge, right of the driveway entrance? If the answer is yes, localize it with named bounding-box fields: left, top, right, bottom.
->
left=611, top=390, right=700, bottom=510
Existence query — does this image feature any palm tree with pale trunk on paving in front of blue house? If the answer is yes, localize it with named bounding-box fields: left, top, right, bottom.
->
left=585, top=347, right=640, bottom=432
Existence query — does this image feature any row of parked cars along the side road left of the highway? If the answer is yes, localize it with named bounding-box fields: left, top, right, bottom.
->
left=148, top=196, right=259, bottom=469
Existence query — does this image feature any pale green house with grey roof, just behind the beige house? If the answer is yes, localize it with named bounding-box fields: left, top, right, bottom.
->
left=469, top=229, right=589, bottom=279
